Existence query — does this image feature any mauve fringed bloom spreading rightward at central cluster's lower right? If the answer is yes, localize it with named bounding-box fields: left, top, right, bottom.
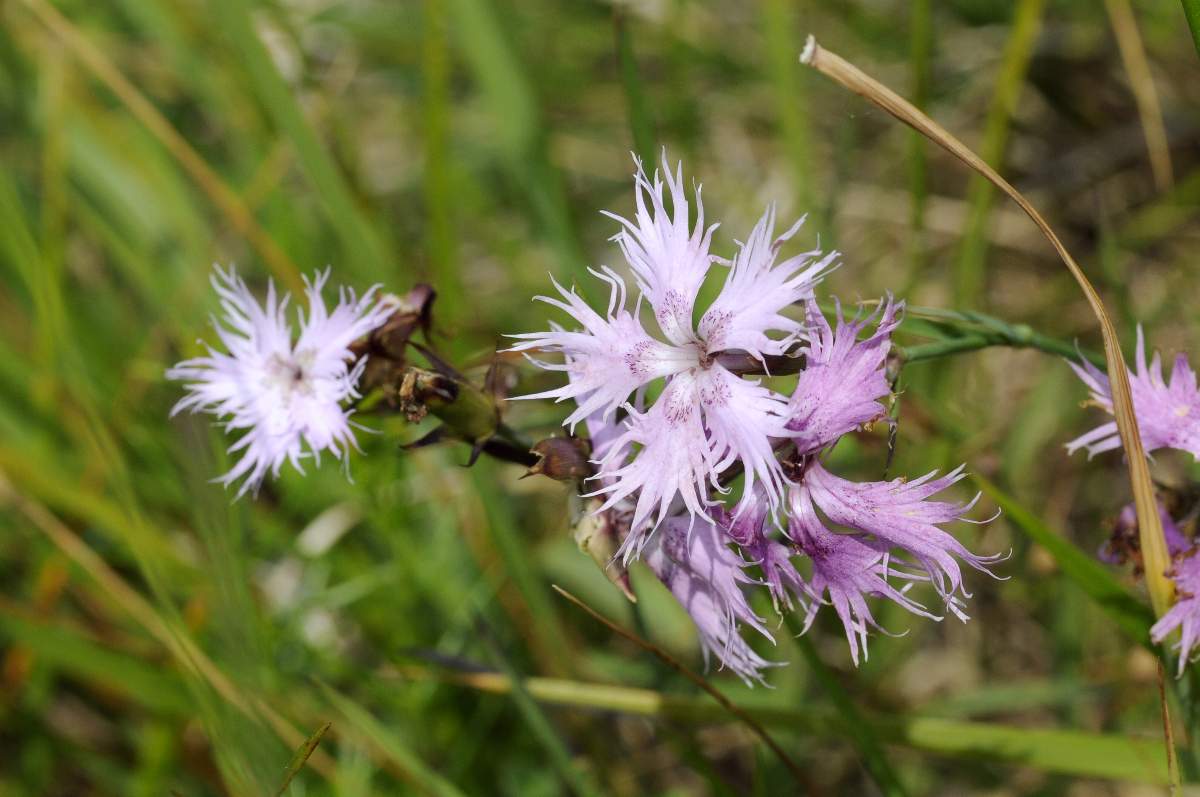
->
left=793, top=459, right=1004, bottom=621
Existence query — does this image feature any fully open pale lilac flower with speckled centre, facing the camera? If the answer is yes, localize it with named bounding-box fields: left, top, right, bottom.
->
left=514, top=156, right=836, bottom=554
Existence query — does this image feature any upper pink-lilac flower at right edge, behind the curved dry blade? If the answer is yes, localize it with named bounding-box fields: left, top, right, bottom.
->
left=1067, top=325, right=1200, bottom=459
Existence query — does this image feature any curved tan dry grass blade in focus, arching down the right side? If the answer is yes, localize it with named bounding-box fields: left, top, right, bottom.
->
left=800, top=36, right=1175, bottom=616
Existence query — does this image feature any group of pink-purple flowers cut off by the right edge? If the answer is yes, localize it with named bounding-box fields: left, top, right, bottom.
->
left=1067, top=326, right=1200, bottom=676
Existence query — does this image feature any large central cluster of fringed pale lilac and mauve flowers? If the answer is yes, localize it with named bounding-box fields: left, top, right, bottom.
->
left=514, top=162, right=998, bottom=682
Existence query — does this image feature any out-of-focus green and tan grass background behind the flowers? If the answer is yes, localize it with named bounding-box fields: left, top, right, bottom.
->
left=0, top=0, right=1200, bottom=796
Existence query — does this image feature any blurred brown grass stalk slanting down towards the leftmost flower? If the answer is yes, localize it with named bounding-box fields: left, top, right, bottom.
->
left=17, top=0, right=304, bottom=293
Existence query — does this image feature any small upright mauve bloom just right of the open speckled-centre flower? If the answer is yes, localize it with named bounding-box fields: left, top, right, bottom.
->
left=787, top=296, right=904, bottom=454
